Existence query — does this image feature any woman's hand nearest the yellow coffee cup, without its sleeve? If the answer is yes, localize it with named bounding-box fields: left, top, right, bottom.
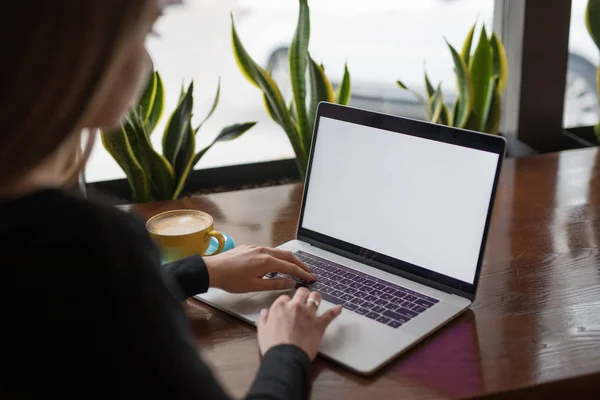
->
left=204, top=246, right=316, bottom=293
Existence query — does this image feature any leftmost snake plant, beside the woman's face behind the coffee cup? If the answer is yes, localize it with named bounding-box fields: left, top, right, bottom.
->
left=100, top=72, right=256, bottom=203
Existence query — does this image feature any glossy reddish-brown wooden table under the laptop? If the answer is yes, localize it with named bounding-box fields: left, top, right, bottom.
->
left=126, top=149, right=600, bottom=399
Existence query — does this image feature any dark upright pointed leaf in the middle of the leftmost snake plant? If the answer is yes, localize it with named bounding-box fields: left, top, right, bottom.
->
left=162, top=82, right=194, bottom=165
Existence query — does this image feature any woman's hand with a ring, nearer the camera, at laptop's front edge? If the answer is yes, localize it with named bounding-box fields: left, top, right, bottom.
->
left=258, top=287, right=342, bottom=360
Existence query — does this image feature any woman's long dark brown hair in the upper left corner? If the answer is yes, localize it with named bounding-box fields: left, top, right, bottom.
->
left=0, top=0, right=151, bottom=187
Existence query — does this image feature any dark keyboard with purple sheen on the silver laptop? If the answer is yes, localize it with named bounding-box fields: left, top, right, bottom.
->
left=269, top=251, right=439, bottom=329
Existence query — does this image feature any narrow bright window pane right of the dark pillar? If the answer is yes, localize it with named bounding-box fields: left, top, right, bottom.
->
left=563, top=0, right=598, bottom=128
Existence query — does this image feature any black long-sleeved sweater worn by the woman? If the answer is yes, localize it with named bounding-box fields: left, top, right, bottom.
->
left=0, top=189, right=310, bottom=399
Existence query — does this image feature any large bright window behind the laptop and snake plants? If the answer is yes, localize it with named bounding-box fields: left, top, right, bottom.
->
left=86, top=0, right=494, bottom=182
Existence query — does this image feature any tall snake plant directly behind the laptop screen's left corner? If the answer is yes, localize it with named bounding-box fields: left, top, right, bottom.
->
left=231, top=0, right=351, bottom=178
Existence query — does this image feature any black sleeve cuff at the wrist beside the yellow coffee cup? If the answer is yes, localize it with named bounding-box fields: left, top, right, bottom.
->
left=163, top=256, right=210, bottom=300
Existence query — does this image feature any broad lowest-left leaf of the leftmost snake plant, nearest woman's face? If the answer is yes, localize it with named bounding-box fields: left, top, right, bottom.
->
left=100, top=127, right=150, bottom=203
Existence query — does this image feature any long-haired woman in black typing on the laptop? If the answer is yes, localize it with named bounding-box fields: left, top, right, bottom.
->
left=0, top=0, right=341, bottom=399
